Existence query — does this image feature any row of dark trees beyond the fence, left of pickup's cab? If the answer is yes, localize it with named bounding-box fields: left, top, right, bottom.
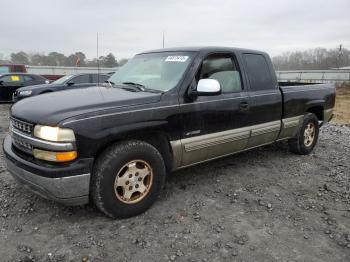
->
left=0, top=51, right=127, bottom=67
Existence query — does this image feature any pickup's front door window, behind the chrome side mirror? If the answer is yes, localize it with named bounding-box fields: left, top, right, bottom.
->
left=198, top=54, right=242, bottom=94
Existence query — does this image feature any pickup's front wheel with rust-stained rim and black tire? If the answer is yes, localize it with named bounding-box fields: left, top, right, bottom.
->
left=90, top=140, right=166, bottom=218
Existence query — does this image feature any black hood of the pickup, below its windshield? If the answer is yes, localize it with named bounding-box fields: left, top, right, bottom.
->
left=11, top=86, right=162, bottom=126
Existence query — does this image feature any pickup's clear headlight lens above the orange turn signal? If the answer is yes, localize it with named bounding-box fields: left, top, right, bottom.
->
left=34, top=125, right=75, bottom=142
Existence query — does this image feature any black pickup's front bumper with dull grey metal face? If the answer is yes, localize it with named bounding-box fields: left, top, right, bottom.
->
left=3, top=135, right=92, bottom=205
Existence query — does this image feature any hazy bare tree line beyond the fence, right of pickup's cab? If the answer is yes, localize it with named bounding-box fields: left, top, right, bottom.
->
left=272, top=48, right=350, bottom=70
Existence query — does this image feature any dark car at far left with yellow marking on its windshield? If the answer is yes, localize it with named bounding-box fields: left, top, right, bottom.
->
left=0, top=73, right=49, bottom=102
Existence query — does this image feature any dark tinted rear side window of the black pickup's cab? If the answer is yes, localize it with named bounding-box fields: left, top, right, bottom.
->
left=243, top=54, right=274, bottom=91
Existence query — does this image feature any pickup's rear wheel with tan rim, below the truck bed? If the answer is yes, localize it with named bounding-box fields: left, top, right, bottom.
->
left=288, top=113, right=319, bottom=155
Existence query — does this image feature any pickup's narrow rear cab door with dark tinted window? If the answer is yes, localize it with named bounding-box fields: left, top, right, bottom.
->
left=242, top=53, right=282, bottom=148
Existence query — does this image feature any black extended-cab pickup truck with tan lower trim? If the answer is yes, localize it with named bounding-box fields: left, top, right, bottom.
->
left=4, top=47, right=335, bottom=218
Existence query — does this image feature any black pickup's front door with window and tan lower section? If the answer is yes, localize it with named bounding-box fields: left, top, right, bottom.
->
left=178, top=52, right=250, bottom=166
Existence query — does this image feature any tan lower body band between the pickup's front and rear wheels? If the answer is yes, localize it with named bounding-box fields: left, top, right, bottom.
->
left=170, top=116, right=303, bottom=170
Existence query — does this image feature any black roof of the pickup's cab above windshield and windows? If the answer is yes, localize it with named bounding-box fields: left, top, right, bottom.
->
left=139, top=46, right=265, bottom=54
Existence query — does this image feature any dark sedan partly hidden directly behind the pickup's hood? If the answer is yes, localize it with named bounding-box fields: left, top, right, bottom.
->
left=13, top=74, right=110, bottom=102
